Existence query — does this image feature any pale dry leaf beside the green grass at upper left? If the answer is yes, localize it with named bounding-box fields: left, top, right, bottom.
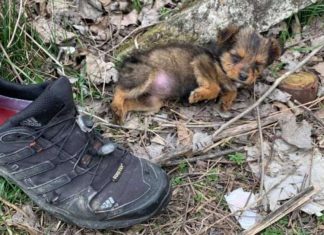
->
left=32, top=17, right=75, bottom=44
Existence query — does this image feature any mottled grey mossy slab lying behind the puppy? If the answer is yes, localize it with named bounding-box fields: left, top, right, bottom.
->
left=115, top=0, right=317, bottom=54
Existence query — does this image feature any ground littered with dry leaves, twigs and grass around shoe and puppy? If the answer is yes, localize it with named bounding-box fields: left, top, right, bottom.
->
left=0, top=0, right=324, bottom=235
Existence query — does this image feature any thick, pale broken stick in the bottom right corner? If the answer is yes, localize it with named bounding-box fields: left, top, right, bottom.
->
left=242, top=186, right=319, bottom=235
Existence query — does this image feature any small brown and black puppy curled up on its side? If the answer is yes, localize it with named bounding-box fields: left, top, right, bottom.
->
left=112, top=26, right=281, bottom=122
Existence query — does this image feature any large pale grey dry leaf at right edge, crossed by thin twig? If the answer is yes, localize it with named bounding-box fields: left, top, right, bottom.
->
left=246, top=139, right=324, bottom=216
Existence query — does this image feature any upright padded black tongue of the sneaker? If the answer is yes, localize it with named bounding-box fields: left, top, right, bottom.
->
left=11, top=78, right=75, bottom=127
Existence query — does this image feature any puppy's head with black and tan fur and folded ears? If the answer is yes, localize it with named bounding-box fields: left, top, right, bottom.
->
left=217, top=26, right=281, bottom=85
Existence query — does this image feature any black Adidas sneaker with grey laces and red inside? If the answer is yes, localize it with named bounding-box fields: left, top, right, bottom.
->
left=0, top=78, right=170, bottom=229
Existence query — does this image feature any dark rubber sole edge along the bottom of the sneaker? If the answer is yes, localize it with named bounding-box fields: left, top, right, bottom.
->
left=0, top=167, right=171, bottom=230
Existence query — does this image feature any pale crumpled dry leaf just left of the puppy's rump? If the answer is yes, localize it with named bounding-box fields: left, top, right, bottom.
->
left=86, top=54, right=118, bottom=85
